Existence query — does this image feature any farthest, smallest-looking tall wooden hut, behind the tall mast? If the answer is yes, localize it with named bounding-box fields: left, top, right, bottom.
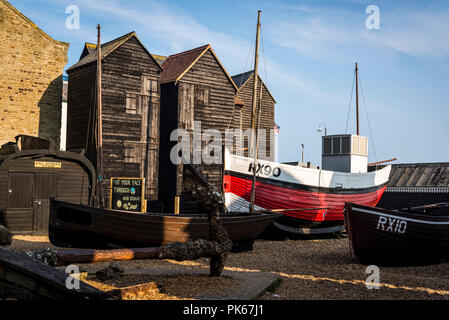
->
left=232, top=71, right=276, bottom=161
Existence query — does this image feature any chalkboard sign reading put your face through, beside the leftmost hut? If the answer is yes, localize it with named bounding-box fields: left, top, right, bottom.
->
left=110, top=178, right=145, bottom=212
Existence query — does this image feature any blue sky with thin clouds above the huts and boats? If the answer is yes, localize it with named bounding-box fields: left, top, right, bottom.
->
left=10, top=0, right=449, bottom=165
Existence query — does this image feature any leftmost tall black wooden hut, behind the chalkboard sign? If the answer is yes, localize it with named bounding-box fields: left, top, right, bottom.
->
left=67, top=32, right=162, bottom=205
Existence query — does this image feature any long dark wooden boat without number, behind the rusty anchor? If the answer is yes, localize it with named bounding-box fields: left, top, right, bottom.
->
left=49, top=199, right=280, bottom=248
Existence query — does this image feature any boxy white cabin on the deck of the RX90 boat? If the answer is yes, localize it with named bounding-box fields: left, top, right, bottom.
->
left=321, top=134, right=368, bottom=173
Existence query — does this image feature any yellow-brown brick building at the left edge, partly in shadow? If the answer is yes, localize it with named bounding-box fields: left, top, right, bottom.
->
left=0, top=0, right=69, bottom=147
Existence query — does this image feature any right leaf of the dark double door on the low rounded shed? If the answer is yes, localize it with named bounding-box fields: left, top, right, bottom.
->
left=33, top=173, right=58, bottom=231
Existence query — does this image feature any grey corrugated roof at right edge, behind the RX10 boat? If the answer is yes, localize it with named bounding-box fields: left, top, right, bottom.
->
left=388, top=162, right=449, bottom=187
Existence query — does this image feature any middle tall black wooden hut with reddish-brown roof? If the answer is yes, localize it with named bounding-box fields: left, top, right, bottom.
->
left=159, top=45, right=240, bottom=212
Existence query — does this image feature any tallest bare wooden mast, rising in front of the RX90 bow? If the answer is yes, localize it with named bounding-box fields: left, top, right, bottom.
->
left=248, top=10, right=262, bottom=213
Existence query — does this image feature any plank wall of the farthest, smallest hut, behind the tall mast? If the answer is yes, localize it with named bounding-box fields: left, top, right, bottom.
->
left=237, top=75, right=275, bottom=161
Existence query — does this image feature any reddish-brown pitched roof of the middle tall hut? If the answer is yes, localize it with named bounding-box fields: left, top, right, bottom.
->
left=161, top=44, right=238, bottom=90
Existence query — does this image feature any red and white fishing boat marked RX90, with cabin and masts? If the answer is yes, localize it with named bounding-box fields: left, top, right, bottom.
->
left=223, top=26, right=394, bottom=234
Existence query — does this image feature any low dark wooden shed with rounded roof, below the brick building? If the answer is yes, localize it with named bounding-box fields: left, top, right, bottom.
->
left=0, top=136, right=95, bottom=231
